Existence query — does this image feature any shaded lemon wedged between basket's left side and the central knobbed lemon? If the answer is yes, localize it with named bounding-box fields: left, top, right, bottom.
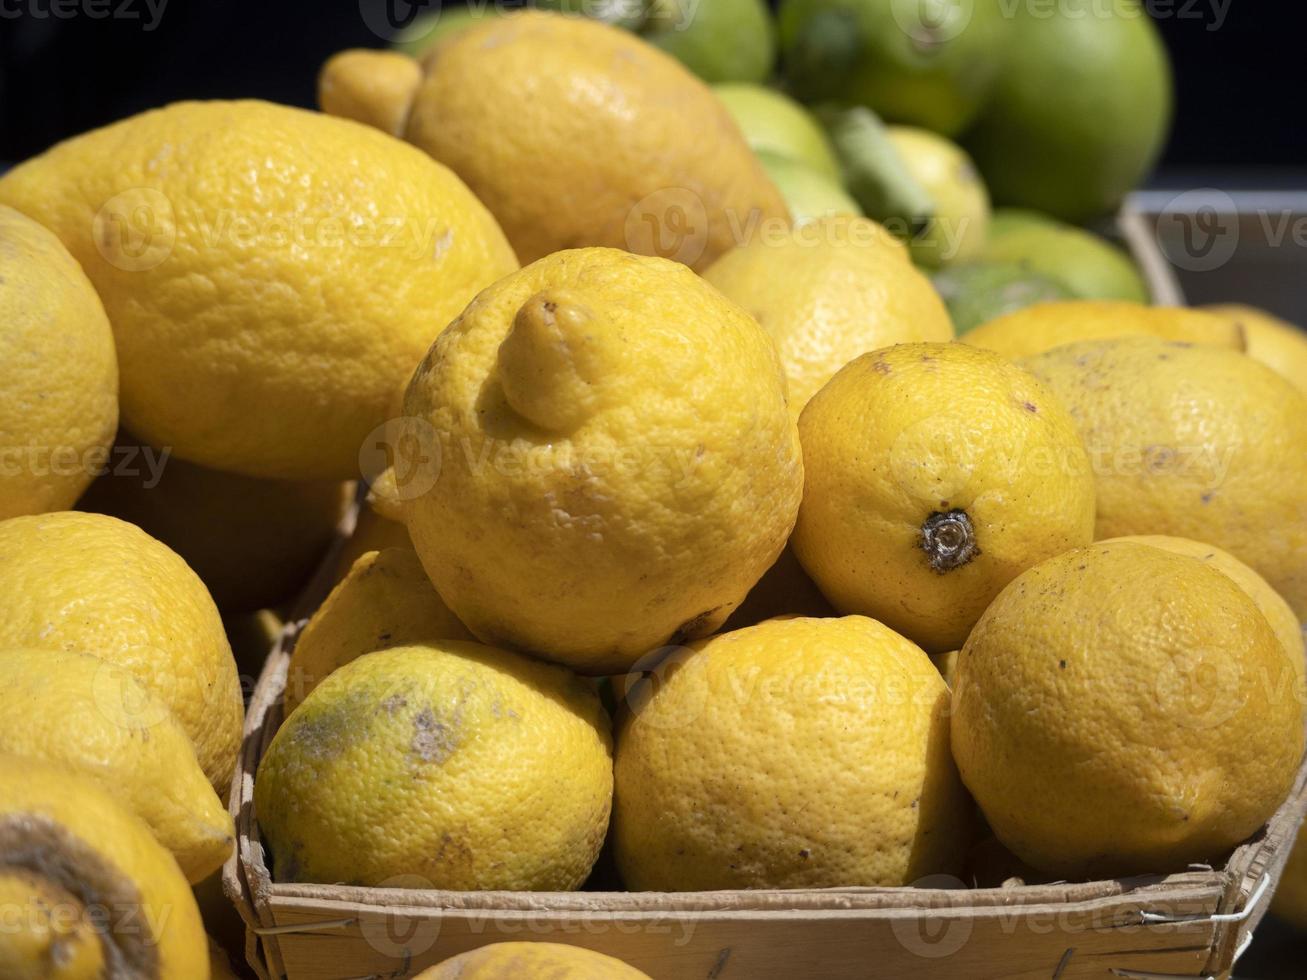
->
left=285, top=547, right=476, bottom=712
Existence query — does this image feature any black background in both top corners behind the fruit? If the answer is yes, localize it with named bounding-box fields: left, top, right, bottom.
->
left=0, top=0, right=1307, bottom=176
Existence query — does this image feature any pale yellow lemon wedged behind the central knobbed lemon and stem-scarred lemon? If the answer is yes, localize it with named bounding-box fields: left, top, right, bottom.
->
left=703, top=217, right=953, bottom=417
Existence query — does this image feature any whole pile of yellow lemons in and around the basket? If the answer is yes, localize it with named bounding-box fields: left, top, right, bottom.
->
left=0, top=5, right=1307, bottom=977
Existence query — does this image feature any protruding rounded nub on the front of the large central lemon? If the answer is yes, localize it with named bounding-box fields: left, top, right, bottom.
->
left=498, top=290, right=606, bottom=431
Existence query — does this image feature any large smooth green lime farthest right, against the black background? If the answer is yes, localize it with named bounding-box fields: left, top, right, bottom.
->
left=966, top=0, right=1171, bottom=222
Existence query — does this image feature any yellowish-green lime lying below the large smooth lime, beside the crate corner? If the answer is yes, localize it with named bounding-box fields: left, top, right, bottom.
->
left=978, top=210, right=1149, bottom=303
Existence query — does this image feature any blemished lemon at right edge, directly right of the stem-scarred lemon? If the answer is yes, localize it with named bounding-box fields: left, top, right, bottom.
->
left=1025, top=338, right=1307, bottom=618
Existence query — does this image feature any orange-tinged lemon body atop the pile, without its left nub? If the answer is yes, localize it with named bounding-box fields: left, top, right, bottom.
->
left=392, top=10, right=788, bottom=268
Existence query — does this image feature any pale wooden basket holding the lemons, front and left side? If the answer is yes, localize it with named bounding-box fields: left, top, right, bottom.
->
left=222, top=514, right=1307, bottom=980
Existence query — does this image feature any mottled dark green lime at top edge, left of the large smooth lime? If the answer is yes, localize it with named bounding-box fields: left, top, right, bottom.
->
left=778, top=0, right=1012, bottom=136
